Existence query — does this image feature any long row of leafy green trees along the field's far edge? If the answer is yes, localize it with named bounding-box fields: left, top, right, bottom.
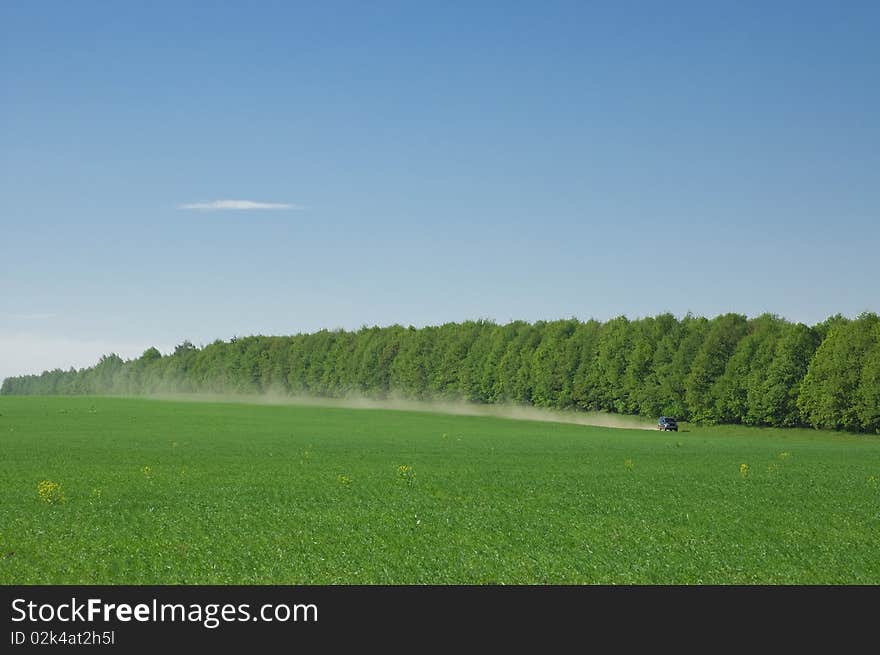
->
left=0, top=313, right=880, bottom=432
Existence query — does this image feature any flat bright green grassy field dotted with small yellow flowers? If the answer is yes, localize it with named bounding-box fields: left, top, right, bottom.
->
left=0, top=397, right=880, bottom=584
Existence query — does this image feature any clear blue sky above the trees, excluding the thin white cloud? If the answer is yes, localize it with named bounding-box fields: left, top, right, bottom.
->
left=0, top=1, right=880, bottom=378
